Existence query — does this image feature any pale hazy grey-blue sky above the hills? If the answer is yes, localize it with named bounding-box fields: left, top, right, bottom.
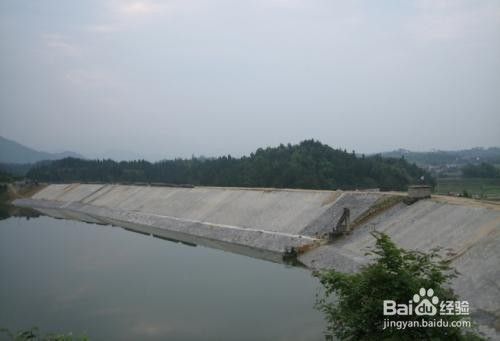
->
left=0, top=0, right=500, bottom=158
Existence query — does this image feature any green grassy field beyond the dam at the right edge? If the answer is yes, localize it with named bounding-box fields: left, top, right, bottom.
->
left=434, top=178, right=500, bottom=201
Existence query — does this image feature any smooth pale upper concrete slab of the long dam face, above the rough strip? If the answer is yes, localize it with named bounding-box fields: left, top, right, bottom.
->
left=33, top=184, right=346, bottom=234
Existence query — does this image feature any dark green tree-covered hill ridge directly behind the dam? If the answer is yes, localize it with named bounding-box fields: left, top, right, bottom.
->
left=27, top=140, right=433, bottom=190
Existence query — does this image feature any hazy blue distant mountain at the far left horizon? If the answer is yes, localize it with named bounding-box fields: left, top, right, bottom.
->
left=0, top=136, right=84, bottom=163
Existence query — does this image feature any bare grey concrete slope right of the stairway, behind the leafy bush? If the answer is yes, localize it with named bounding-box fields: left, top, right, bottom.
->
left=299, top=198, right=500, bottom=339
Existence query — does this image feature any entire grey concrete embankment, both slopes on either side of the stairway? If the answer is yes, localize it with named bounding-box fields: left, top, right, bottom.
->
left=14, top=184, right=500, bottom=337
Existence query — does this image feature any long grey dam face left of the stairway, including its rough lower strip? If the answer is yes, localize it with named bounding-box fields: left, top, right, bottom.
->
left=15, top=184, right=383, bottom=254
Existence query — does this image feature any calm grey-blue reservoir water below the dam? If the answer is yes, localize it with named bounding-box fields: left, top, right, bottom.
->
left=0, top=217, right=325, bottom=340
